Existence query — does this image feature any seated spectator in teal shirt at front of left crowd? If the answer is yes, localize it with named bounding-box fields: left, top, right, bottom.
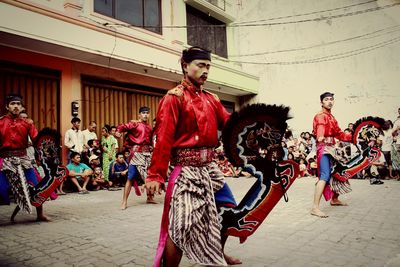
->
left=67, top=152, right=93, bottom=194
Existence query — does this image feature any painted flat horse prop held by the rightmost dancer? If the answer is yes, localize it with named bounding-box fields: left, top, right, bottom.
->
left=331, top=117, right=385, bottom=182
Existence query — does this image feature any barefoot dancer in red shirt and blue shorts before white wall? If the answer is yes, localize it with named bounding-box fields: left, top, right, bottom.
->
left=311, top=92, right=352, bottom=218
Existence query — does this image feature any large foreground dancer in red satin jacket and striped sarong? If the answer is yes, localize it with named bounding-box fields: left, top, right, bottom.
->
left=146, top=47, right=240, bottom=266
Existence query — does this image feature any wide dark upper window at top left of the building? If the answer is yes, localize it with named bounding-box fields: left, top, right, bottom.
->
left=94, top=0, right=162, bottom=34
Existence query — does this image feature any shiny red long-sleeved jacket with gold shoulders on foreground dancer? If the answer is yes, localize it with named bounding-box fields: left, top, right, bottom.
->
left=146, top=80, right=230, bottom=183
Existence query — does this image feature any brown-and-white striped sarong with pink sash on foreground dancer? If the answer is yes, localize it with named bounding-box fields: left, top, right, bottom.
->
left=154, top=162, right=226, bottom=266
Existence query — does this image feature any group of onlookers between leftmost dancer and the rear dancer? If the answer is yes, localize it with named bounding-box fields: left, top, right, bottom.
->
left=57, top=120, right=129, bottom=194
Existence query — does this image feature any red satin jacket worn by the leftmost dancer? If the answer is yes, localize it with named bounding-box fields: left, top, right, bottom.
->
left=0, top=114, right=38, bottom=152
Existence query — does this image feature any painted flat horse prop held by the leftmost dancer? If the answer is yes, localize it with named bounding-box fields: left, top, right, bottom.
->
left=31, top=128, right=68, bottom=207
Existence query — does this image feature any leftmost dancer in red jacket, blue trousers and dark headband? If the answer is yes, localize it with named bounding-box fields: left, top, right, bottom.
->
left=0, top=94, right=49, bottom=221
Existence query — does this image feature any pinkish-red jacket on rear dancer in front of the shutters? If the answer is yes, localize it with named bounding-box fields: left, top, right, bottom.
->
left=117, top=121, right=152, bottom=147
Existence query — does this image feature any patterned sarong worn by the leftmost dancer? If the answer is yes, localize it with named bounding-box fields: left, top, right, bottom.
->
left=1, top=156, right=32, bottom=213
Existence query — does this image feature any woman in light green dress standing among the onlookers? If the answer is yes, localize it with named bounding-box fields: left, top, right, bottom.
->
left=101, top=124, right=117, bottom=181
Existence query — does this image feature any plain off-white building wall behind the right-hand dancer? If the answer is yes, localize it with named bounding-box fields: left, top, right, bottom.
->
left=235, top=0, right=400, bottom=134
